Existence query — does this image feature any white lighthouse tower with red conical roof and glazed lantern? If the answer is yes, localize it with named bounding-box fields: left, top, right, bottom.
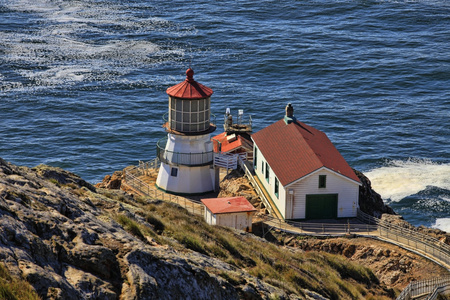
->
left=156, top=68, right=218, bottom=195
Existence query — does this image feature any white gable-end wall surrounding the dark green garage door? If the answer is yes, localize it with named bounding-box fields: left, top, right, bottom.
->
left=287, top=168, right=359, bottom=219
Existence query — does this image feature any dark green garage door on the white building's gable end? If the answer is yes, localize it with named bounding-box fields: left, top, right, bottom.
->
left=306, top=194, right=338, bottom=219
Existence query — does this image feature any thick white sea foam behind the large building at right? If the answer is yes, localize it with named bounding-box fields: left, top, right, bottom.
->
left=365, top=159, right=450, bottom=201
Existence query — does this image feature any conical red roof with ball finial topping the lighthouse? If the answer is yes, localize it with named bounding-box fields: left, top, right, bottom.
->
left=166, top=68, right=213, bottom=99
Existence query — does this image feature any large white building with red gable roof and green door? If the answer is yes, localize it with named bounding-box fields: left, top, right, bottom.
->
left=252, top=104, right=361, bottom=219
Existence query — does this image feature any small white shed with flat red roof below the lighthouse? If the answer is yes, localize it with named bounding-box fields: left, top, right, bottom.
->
left=202, top=196, right=256, bottom=232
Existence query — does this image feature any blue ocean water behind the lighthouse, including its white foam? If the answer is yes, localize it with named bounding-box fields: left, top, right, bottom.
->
left=0, top=0, right=450, bottom=231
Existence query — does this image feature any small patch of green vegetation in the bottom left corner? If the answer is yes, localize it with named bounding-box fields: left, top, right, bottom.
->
left=0, top=263, right=40, bottom=300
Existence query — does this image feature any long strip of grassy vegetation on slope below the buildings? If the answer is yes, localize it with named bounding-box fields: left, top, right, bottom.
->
left=116, top=199, right=388, bottom=299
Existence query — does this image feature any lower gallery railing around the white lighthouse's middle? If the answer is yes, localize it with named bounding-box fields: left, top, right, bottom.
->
left=156, top=137, right=214, bottom=167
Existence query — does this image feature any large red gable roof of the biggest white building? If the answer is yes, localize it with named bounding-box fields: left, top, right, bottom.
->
left=252, top=119, right=360, bottom=186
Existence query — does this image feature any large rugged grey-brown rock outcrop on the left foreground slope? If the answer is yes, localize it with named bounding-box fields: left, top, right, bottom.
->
left=0, top=159, right=284, bottom=300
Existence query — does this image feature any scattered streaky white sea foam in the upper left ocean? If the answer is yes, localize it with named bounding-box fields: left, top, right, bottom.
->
left=0, top=0, right=184, bottom=90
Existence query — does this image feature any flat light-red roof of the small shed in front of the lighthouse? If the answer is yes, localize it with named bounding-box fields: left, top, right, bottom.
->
left=202, top=196, right=256, bottom=214
